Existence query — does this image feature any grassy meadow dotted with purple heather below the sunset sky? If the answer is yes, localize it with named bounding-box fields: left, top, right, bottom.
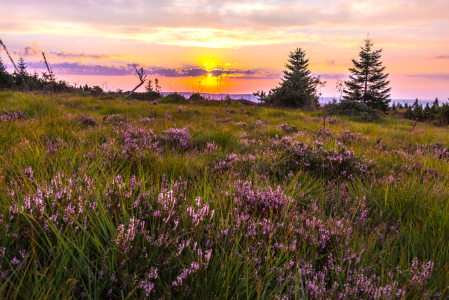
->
left=0, top=92, right=449, bottom=299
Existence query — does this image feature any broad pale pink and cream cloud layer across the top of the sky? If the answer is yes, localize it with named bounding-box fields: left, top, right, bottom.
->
left=0, top=0, right=449, bottom=48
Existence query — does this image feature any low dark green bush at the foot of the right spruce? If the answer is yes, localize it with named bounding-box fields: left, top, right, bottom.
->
left=327, top=100, right=380, bottom=121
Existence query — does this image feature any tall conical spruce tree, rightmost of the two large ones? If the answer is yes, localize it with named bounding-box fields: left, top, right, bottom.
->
left=343, top=37, right=391, bottom=111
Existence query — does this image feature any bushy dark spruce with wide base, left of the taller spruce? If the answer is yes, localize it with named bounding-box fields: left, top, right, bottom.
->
left=254, top=48, right=324, bottom=107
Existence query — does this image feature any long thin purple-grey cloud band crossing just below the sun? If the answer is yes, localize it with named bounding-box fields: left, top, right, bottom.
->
left=21, top=61, right=280, bottom=78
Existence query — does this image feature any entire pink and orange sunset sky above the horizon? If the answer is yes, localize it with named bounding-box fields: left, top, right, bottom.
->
left=0, top=0, right=449, bottom=100
